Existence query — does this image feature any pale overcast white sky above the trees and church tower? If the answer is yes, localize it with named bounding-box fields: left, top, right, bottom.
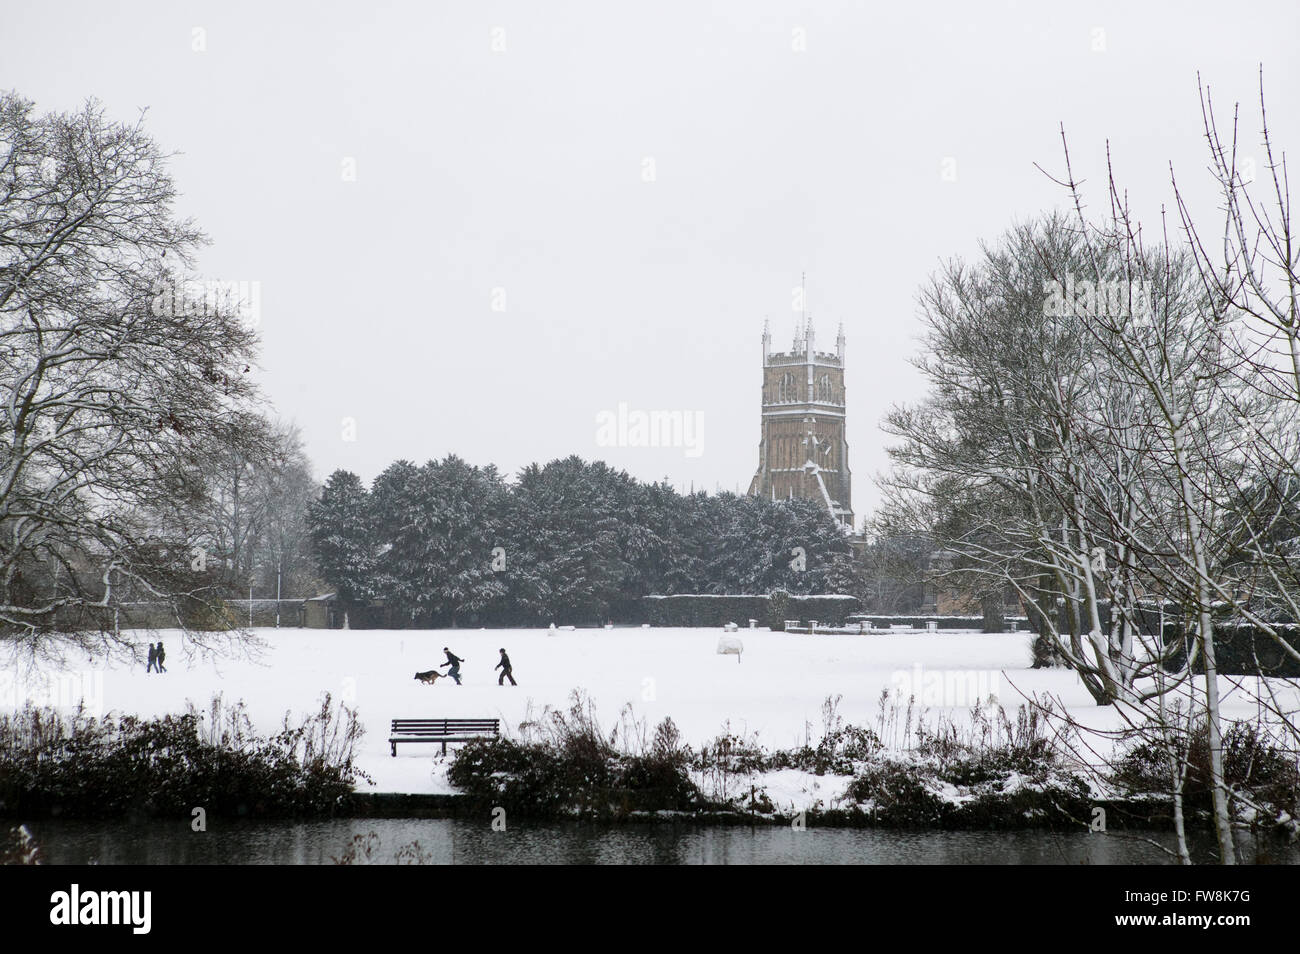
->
left=0, top=0, right=1300, bottom=516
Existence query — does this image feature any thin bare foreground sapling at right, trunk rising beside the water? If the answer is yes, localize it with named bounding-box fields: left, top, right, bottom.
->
left=1013, top=75, right=1300, bottom=864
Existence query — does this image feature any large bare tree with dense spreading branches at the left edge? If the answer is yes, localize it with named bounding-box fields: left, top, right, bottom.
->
left=0, top=94, right=256, bottom=649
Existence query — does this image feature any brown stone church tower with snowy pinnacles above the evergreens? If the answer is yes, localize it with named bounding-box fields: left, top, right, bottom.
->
left=749, top=318, right=854, bottom=532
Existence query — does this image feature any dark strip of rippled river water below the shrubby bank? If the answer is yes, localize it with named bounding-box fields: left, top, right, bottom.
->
left=29, top=819, right=1300, bottom=864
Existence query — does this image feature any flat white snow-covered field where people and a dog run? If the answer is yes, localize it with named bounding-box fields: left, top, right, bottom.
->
left=0, top=629, right=1295, bottom=802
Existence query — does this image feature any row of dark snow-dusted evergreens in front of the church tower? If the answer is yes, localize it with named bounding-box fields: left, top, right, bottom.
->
left=306, top=456, right=861, bottom=625
